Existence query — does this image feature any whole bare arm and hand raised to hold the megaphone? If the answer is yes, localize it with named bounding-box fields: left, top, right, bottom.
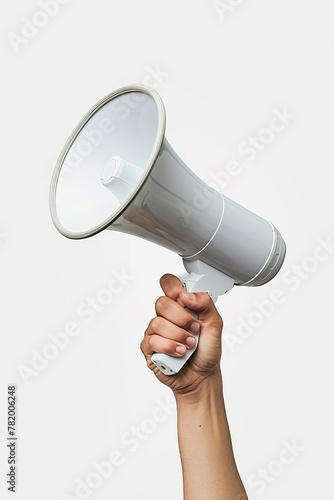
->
left=141, top=274, right=247, bottom=500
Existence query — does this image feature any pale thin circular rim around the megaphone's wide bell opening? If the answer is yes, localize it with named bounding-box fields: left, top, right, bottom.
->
left=49, top=84, right=166, bottom=239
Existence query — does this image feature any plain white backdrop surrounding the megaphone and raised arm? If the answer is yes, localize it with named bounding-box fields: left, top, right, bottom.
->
left=0, top=0, right=334, bottom=500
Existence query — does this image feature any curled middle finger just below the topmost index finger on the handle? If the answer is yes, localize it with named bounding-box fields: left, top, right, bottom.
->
left=155, top=297, right=200, bottom=334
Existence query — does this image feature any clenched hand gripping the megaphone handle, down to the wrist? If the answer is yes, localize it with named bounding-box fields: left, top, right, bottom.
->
left=140, top=274, right=223, bottom=395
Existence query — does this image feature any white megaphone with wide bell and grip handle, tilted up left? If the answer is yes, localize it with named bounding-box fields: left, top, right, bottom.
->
left=50, top=85, right=286, bottom=375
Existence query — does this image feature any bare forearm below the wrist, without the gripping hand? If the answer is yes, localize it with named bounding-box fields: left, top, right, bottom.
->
left=176, top=372, right=247, bottom=500
